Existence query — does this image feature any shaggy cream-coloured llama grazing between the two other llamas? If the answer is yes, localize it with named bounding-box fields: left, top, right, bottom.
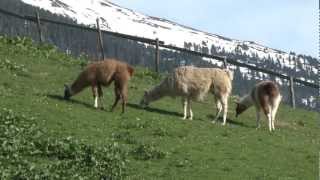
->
left=140, top=66, right=233, bottom=125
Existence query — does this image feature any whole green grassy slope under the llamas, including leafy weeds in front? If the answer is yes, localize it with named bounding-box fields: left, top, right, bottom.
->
left=0, top=37, right=319, bottom=180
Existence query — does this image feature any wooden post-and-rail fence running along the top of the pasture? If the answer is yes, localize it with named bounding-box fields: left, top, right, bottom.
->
left=0, top=9, right=319, bottom=108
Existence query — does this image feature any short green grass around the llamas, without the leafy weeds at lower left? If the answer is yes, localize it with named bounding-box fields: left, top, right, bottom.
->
left=0, top=37, right=319, bottom=179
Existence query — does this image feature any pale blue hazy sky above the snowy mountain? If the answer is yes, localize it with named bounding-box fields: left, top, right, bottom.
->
left=111, top=0, right=319, bottom=57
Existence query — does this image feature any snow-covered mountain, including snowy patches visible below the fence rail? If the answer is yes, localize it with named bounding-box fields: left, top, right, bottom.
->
left=21, top=0, right=318, bottom=107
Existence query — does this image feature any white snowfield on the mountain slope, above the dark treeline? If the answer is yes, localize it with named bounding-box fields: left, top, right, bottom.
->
left=22, top=0, right=317, bottom=73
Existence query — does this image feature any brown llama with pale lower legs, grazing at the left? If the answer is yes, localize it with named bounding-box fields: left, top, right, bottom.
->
left=64, top=59, right=134, bottom=113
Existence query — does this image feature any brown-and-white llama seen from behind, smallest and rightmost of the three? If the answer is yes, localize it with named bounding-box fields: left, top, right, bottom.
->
left=236, top=81, right=282, bottom=131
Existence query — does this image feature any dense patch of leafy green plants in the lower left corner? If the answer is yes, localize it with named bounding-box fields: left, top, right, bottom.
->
left=0, top=109, right=128, bottom=179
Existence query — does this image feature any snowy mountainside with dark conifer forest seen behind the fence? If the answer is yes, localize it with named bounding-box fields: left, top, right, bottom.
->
left=0, top=0, right=318, bottom=109
